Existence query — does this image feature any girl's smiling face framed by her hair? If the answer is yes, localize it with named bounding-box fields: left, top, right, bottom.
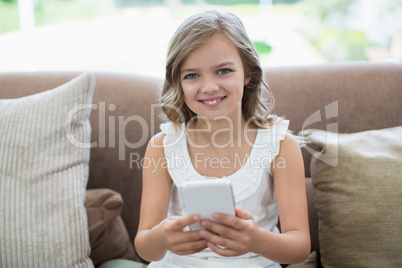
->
left=180, top=34, right=250, bottom=119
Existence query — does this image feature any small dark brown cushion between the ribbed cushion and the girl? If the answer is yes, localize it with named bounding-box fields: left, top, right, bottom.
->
left=85, top=189, right=135, bottom=265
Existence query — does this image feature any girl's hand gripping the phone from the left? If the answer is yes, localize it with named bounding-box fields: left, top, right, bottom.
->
left=157, top=215, right=207, bottom=255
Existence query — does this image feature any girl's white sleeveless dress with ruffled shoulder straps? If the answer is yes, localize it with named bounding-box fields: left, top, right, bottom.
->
left=148, top=119, right=289, bottom=268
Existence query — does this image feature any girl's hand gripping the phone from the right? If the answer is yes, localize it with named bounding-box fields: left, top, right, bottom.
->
left=199, top=208, right=260, bottom=257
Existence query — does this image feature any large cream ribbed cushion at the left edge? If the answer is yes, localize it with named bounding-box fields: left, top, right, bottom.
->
left=0, top=73, right=95, bottom=267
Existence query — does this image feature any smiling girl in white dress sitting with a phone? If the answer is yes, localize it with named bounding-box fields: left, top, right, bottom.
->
left=135, top=11, right=310, bottom=268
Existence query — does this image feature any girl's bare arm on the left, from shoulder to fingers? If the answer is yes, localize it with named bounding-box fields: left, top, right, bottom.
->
left=135, top=134, right=206, bottom=261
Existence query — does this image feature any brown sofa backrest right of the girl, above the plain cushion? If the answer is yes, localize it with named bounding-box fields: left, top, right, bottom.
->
left=265, top=62, right=402, bottom=177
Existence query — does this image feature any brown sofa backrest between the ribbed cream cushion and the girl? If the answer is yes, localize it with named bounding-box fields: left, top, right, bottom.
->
left=88, top=73, right=162, bottom=253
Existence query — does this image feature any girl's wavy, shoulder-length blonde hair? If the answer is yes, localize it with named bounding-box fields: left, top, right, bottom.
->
left=161, top=10, right=274, bottom=129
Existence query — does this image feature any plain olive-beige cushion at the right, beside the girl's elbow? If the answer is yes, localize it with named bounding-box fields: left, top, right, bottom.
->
left=304, top=127, right=402, bottom=267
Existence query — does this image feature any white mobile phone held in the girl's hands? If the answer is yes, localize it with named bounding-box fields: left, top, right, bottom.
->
left=181, top=179, right=235, bottom=231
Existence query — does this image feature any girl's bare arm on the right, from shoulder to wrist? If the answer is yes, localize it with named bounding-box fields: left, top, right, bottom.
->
left=256, top=134, right=310, bottom=263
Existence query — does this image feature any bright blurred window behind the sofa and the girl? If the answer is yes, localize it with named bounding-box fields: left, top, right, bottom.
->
left=0, top=0, right=402, bottom=77
